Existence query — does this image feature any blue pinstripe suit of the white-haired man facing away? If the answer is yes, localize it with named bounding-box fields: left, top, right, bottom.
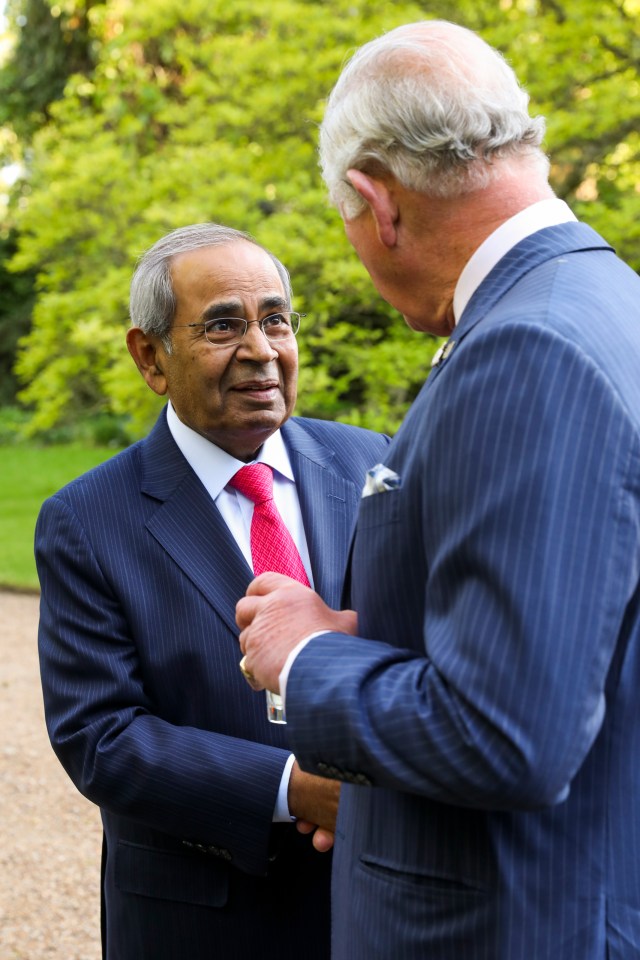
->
left=287, top=223, right=640, bottom=960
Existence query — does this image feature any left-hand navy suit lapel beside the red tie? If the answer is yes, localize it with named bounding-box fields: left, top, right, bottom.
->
left=141, top=412, right=253, bottom=634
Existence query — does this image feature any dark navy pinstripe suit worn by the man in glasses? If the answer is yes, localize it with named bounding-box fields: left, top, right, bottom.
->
left=36, top=413, right=387, bottom=960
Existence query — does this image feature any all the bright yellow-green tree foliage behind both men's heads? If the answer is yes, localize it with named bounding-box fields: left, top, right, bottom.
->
left=3, top=0, right=640, bottom=435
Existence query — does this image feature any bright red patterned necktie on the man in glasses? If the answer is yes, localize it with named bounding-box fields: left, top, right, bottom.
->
left=229, top=463, right=310, bottom=587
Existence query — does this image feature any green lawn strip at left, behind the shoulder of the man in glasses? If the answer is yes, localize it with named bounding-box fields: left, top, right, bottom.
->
left=0, top=444, right=122, bottom=588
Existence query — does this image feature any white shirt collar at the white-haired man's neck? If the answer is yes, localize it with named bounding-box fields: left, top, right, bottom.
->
left=453, top=197, right=576, bottom=324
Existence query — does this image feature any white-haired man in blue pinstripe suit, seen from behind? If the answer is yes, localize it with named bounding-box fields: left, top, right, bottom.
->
left=237, top=21, right=640, bottom=960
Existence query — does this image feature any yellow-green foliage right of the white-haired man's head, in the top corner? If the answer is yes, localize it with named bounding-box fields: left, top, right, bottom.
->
left=467, top=0, right=640, bottom=258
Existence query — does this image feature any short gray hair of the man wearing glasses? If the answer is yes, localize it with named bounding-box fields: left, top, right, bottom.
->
left=129, top=223, right=292, bottom=353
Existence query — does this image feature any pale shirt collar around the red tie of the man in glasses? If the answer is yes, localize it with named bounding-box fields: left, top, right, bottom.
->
left=167, top=403, right=295, bottom=500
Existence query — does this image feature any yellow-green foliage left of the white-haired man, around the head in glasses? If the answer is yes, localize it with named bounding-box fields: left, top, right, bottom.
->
left=6, top=0, right=432, bottom=432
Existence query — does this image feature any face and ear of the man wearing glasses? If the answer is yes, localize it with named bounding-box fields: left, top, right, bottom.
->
left=127, top=240, right=298, bottom=460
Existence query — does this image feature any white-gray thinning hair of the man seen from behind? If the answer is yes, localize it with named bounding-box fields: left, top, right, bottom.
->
left=320, top=20, right=549, bottom=217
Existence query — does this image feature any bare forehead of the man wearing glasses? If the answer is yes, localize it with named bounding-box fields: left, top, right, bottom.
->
left=171, top=240, right=285, bottom=305
